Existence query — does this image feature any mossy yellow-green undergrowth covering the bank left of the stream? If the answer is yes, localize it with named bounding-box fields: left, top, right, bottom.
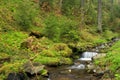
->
left=0, top=31, right=72, bottom=79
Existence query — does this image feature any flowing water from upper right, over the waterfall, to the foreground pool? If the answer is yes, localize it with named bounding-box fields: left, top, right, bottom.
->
left=48, top=38, right=120, bottom=80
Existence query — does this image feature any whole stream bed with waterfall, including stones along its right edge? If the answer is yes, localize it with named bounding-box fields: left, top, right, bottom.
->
left=45, top=38, right=120, bottom=80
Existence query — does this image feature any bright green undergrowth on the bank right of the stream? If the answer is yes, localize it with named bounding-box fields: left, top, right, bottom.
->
left=95, top=41, right=120, bottom=80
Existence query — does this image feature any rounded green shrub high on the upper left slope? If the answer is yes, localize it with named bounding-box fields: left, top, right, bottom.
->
left=15, top=1, right=38, bottom=30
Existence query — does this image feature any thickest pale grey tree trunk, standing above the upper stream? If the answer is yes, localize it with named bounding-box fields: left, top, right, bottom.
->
left=98, top=0, right=102, bottom=33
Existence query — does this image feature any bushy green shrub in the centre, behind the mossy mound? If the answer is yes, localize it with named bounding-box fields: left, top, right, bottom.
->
left=43, top=15, right=79, bottom=42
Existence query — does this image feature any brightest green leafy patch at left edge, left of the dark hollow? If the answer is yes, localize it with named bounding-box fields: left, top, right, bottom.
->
left=0, top=31, right=27, bottom=48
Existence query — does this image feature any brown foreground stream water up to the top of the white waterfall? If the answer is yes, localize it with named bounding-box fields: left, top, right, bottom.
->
left=46, top=52, right=98, bottom=80
